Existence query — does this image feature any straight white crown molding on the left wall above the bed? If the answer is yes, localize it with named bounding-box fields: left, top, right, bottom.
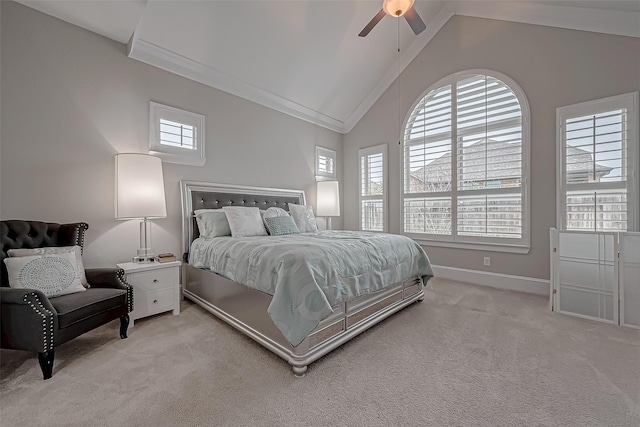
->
left=127, top=37, right=344, bottom=133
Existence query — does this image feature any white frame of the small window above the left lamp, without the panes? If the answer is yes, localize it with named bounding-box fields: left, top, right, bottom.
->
left=149, top=101, right=207, bottom=166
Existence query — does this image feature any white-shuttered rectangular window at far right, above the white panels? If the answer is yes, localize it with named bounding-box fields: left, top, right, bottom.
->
left=557, top=92, right=639, bottom=231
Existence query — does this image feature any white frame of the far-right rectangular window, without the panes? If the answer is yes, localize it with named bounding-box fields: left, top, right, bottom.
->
left=556, top=91, right=640, bottom=233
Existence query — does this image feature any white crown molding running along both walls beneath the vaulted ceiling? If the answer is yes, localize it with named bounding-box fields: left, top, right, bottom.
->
left=128, top=0, right=640, bottom=134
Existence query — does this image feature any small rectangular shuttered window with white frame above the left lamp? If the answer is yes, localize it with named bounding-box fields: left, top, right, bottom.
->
left=149, top=102, right=206, bottom=166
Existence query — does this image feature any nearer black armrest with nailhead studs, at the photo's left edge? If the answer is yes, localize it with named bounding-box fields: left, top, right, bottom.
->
left=0, top=287, right=58, bottom=353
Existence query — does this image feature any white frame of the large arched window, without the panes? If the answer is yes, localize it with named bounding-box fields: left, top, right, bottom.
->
left=400, top=69, right=531, bottom=253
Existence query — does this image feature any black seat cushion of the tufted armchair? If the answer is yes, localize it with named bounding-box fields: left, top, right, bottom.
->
left=49, top=288, right=127, bottom=329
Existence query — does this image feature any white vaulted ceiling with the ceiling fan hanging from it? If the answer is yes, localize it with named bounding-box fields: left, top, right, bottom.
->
left=19, top=0, right=640, bottom=133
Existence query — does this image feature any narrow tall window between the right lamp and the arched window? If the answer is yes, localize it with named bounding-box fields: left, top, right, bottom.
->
left=358, top=144, right=387, bottom=231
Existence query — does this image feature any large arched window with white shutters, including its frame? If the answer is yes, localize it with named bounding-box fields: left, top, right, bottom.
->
left=403, top=71, right=529, bottom=248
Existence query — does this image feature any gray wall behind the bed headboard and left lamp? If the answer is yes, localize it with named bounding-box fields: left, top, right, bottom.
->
left=0, top=1, right=342, bottom=267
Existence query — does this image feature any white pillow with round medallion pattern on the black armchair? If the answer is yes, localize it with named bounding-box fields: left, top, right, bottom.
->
left=4, top=252, right=86, bottom=297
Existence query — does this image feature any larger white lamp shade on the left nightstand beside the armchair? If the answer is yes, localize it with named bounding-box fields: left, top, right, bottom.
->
left=116, top=154, right=167, bottom=219
